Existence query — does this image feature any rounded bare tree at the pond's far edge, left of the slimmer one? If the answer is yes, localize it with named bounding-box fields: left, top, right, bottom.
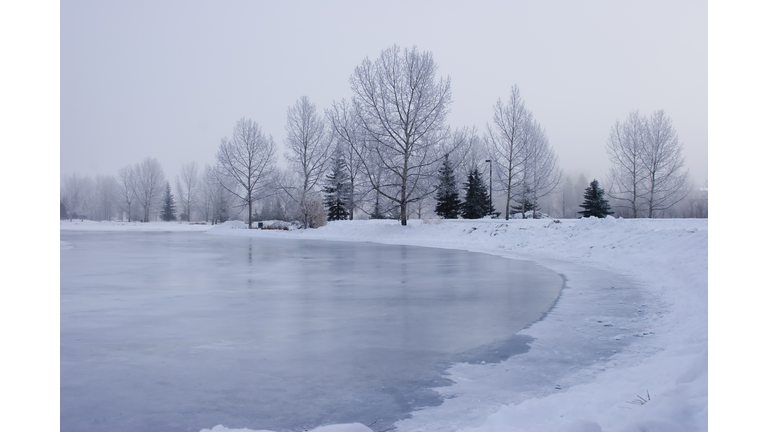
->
left=216, top=118, right=277, bottom=228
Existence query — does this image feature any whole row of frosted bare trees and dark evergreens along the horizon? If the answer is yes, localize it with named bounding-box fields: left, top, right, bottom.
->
left=60, top=45, right=707, bottom=227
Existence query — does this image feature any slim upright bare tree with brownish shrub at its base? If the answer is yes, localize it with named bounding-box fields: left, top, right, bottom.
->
left=281, top=96, right=331, bottom=226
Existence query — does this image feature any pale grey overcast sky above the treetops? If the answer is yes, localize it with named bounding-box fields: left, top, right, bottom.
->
left=60, top=1, right=708, bottom=184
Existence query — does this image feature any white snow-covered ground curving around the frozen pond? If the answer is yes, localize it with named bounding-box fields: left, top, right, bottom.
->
left=60, top=217, right=708, bottom=432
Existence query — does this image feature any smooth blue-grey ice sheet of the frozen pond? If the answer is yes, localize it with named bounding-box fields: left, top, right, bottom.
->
left=60, top=231, right=563, bottom=432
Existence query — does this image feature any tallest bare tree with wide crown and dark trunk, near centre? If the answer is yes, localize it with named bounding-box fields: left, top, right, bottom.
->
left=349, top=45, right=451, bottom=225
